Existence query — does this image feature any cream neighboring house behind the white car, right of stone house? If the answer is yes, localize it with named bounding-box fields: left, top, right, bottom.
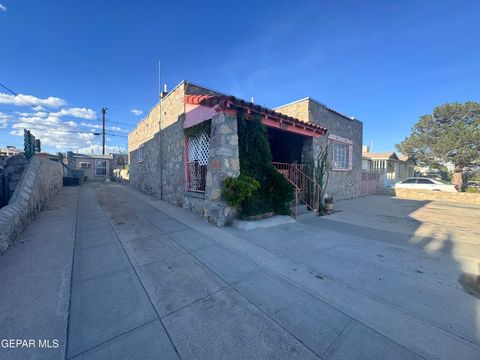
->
left=362, top=146, right=415, bottom=186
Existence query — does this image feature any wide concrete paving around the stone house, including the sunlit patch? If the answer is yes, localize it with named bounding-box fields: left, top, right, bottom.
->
left=0, top=184, right=480, bottom=359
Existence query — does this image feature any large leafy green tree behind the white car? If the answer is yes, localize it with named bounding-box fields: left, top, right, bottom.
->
left=396, top=102, right=480, bottom=187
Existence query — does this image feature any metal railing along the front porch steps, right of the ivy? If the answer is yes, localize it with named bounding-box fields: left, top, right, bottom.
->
left=272, top=162, right=321, bottom=218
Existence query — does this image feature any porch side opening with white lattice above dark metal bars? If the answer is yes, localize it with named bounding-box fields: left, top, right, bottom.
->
left=185, top=132, right=210, bottom=193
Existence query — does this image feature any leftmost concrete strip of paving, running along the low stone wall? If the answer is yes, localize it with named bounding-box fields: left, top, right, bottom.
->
left=0, top=188, right=78, bottom=360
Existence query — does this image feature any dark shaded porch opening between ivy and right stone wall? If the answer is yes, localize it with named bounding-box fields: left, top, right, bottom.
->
left=267, top=127, right=305, bottom=164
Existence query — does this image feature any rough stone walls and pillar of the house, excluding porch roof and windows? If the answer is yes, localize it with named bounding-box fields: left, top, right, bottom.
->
left=128, top=82, right=362, bottom=226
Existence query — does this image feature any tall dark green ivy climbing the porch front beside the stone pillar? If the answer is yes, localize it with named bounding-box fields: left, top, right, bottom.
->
left=237, top=111, right=294, bottom=216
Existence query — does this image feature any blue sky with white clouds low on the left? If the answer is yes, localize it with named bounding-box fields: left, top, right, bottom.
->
left=0, top=0, right=480, bottom=152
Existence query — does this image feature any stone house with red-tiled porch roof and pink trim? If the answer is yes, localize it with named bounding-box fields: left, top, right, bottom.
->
left=128, top=81, right=362, bottom=225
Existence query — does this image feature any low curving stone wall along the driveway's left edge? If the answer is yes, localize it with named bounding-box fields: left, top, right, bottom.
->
left=0, top=156, right=63, bottom=254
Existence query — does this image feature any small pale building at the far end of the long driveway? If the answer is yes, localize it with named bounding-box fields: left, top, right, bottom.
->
left=64, top=151, right=113, bottom=181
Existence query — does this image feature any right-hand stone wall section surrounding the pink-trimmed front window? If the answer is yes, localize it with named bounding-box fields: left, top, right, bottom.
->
left=275, top=98, right=363, bottom=200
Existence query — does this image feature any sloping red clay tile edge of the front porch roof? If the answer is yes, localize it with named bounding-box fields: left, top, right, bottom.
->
left=185, top=95, right=327, bottom=136
